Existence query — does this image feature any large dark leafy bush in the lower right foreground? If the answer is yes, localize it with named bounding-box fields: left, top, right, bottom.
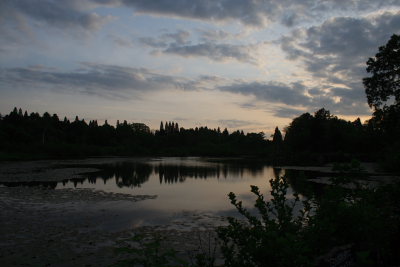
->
left=218, top=174, right=400, bottom=266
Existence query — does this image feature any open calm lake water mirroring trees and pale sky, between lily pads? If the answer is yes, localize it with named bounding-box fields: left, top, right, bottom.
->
left=4, top=157, right=306, bottom=228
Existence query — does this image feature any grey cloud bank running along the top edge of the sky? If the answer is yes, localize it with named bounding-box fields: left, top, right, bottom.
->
left=92, top=0, right=400, bottom=26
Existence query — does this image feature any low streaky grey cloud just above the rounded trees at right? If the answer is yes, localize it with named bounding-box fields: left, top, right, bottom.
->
left=217, top=82, right=369, bottom=118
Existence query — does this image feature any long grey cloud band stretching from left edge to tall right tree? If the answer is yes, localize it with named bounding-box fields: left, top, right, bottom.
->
left=0, top=63, right=367, bottom=118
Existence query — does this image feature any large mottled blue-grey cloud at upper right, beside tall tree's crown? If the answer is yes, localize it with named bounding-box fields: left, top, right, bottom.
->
left=281, top=12, right=400, bottom=84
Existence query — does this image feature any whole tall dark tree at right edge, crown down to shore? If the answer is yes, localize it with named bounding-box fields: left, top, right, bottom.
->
left=363, top=34, right=400, bottom=171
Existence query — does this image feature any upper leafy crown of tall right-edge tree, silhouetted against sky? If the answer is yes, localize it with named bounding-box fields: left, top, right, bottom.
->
left=363, top=34, right=400, bottom=110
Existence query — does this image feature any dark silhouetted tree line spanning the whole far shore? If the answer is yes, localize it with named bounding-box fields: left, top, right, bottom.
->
left=0, top=106, right=400, bottom=170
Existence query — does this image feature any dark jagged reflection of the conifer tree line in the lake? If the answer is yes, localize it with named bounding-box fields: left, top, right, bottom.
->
left=2, top=159, right=274, bottom=189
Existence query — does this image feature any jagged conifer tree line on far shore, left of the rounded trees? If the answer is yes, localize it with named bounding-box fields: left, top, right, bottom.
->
left=0, top=108, right=270, bottom=159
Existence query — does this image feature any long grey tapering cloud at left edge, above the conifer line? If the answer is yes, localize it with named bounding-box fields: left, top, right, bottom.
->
left=0, top=63, right=187, bottom=98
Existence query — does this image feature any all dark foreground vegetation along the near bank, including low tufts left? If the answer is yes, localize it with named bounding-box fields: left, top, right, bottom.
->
left=117, top=168, right=400, bottom=267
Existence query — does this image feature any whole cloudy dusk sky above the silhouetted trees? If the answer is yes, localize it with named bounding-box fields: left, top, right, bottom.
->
left=0, top=0, right=400, bottom=137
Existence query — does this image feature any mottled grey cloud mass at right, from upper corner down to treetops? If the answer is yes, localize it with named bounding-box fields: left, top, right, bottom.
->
left=280, top=12, right=400, bottom=114
